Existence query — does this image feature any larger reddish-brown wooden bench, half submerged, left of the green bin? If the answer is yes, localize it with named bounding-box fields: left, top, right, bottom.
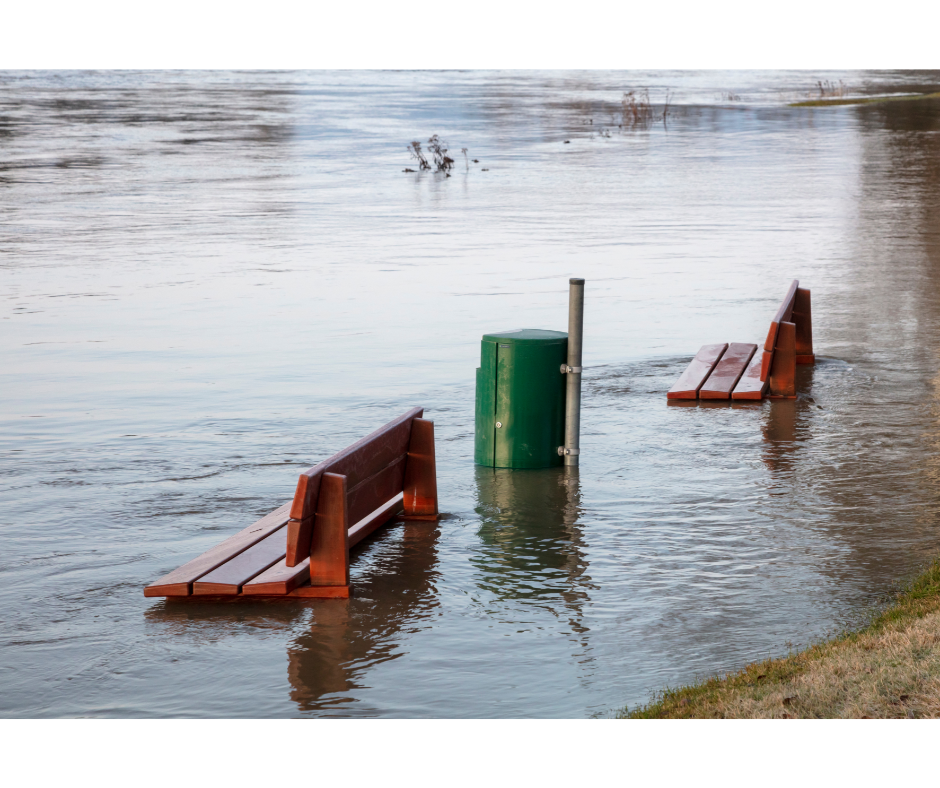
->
left=144, top=408, right=439, bottom=599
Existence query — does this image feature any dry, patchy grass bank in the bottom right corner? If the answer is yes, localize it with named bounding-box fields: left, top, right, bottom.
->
left=620, top=560, right=940, bottom=719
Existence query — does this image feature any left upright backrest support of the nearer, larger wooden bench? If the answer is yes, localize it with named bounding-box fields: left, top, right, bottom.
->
left=310, top=473, right=349, bottom=586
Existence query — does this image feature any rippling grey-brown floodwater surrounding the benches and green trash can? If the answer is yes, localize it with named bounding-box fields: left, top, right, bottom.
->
left=0, top=72, right=940, bottom=717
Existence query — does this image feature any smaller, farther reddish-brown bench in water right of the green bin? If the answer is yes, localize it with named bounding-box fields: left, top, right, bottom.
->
left=666, top=279, right=816, bottom=400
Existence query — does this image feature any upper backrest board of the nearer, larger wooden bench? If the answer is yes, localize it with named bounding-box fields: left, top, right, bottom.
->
left=290, top=408, right=424, bottom=520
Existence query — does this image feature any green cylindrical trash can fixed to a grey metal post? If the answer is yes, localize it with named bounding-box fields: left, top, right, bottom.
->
left=474, top=328, right=568, bottom=468
